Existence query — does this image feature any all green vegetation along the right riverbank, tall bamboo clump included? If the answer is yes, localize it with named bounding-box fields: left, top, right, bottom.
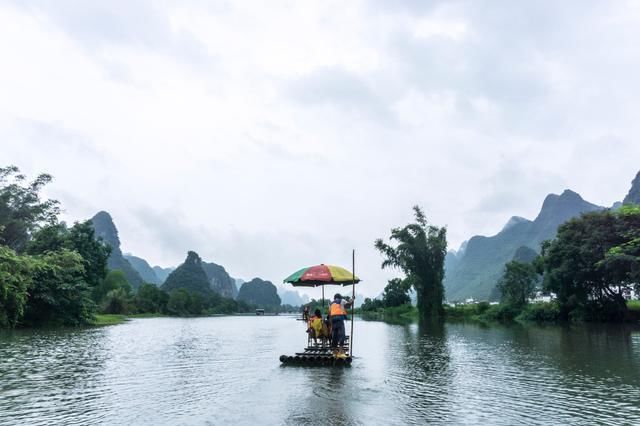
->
left=370, top=203, right=640, bottom=323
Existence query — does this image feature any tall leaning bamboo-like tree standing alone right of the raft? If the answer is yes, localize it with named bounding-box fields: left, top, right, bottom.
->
left=375, top=206, right=447, bottom=319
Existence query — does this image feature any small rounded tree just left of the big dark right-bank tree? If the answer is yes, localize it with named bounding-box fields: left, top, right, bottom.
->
left=497, top=260, right=538, bottom=307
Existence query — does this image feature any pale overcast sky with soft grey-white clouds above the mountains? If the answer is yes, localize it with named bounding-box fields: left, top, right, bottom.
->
left=0, top=0, right=640, bottom=296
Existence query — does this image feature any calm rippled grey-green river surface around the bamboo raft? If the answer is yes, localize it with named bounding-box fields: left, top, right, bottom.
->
left=0, top=316, right=640, bottom=425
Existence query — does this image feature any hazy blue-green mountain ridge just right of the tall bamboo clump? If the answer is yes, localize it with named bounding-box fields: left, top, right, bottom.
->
left=444, top=190, right=604, bottom=300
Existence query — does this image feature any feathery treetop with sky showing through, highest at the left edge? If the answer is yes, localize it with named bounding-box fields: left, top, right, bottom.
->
left=0, top=166, right=60, bottom=253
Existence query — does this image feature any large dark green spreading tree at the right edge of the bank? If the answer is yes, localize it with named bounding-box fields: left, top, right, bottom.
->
left=542, top=205, right=640, bottom=320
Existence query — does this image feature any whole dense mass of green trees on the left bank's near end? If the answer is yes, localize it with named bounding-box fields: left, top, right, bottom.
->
left=0, top=167, right=109, bottom=327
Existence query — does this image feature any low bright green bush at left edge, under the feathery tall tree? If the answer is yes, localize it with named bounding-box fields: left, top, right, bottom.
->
left=0, top=246, right=34, bottom=328
